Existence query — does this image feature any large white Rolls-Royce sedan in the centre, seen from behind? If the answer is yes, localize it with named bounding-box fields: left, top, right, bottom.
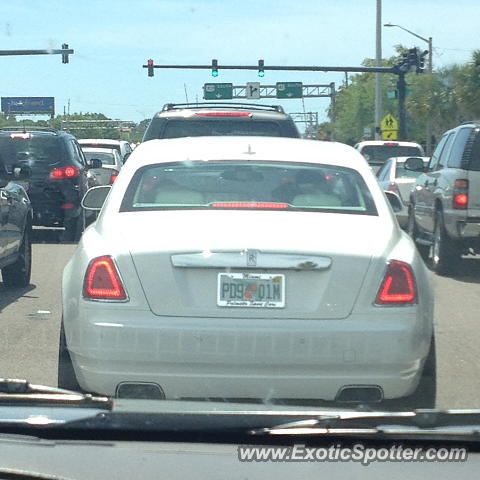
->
left=58, top=137, right=435, bottom=406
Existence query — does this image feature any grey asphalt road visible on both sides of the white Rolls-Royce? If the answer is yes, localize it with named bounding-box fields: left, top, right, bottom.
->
left=0, top=233, right=480, bottom=408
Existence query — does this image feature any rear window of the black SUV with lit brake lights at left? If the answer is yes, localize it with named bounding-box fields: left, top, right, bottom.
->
left=0, top=134, right=64, bottom=173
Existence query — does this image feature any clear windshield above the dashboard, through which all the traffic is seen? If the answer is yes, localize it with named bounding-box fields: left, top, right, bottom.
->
left=0, top=0, right=480, bottom=450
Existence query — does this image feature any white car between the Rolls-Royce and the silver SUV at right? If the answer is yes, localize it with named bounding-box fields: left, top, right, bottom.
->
left=377, top=157, right=430, bottom=228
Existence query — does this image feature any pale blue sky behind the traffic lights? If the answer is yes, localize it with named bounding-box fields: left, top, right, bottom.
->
left=0, top=0, right=480, bottom=126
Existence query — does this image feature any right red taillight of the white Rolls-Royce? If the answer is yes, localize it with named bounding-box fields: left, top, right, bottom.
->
left=375, top=260, right=417, bottom=305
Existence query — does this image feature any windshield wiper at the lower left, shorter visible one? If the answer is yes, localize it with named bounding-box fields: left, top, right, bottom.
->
left=0, top=378, right=113, bottom=410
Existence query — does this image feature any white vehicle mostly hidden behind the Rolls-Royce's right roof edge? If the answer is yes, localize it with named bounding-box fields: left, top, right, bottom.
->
left=354, top=140, right=425, bottom=173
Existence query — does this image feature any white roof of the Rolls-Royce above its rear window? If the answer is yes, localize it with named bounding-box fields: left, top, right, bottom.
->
left=127, top=136, right=370, bottom=171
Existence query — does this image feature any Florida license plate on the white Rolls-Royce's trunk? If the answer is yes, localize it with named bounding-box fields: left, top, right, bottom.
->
left=217, top=273, right=285, bottom=308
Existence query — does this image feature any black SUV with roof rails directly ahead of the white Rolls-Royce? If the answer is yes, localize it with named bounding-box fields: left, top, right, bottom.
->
left=143, top=102, right=301, bottom=142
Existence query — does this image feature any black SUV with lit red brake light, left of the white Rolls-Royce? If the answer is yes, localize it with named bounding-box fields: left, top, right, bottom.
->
left=0, top=127, right=99, bottom=241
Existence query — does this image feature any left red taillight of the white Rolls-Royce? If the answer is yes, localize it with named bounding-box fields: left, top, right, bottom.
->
left=83, top=255, right=127, bottom=300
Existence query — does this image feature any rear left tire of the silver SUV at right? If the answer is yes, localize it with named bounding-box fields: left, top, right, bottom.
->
left=431, top=211, right=461, bottom=275
